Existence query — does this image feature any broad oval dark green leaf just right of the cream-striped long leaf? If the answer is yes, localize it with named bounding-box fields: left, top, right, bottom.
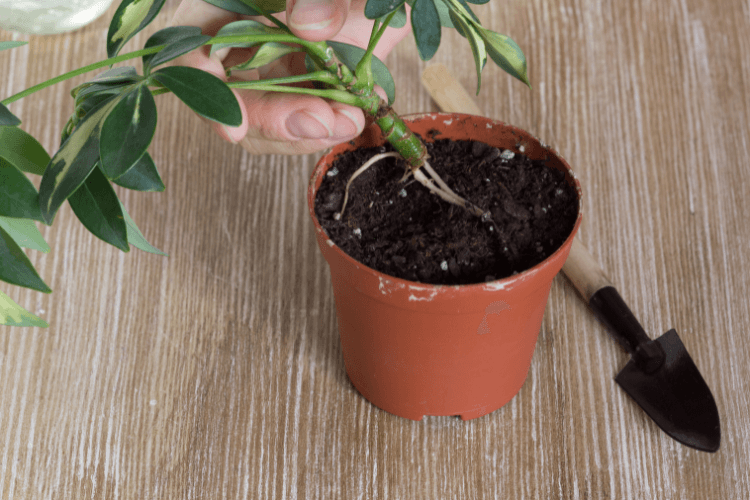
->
left=99, top=85, right=156, bottom=179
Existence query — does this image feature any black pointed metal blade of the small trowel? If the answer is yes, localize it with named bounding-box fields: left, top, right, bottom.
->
left=615, top=330, right=721, bottom=452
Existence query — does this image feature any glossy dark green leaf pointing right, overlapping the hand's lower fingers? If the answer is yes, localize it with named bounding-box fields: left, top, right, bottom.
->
left=151, top=66, right=242, bottom=127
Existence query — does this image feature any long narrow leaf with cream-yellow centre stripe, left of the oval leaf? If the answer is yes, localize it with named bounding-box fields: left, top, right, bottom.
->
left=39, top=99, right=118, bottom=224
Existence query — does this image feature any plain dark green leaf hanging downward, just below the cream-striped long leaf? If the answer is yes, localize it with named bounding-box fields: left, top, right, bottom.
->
left=68, top=168, right=130, bottom=252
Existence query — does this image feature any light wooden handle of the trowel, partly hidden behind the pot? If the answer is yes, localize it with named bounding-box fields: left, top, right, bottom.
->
left=422, top=64, right=612, bottom=302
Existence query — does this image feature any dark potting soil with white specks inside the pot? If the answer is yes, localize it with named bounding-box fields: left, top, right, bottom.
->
left=315, top=139, right=578, bottom=284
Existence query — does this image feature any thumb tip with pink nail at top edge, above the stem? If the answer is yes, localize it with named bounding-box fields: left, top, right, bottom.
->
left=286, top=0, right=351, bottom=42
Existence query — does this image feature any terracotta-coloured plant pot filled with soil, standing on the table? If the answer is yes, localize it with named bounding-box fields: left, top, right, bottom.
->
left=307, top=113, right=581, bottom=420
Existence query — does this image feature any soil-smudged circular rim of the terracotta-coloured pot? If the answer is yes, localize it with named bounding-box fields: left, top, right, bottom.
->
left=307, top=112, right=583, bottom=292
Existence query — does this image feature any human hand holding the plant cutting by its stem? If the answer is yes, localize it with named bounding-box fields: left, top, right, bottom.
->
left=172, top=0, right=411, bottom=154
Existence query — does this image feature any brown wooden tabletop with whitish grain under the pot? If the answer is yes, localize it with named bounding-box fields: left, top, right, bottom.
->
left=0, top=0, right=750, bottom=499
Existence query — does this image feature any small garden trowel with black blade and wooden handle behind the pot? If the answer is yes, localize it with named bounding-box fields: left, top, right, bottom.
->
left=422, top=65, right=721, bottom=452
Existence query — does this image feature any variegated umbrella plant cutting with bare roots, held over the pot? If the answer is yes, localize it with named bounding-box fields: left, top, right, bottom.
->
left=0, top=0, right=528, bottom=327
